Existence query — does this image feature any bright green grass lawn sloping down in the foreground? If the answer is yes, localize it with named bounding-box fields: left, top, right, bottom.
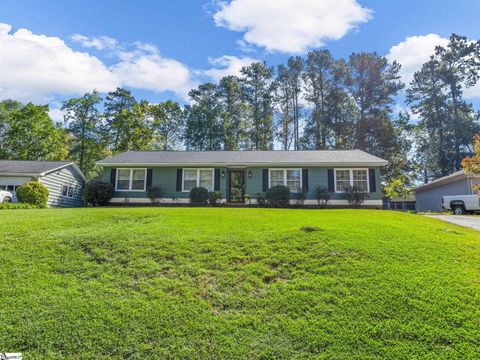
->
left=0, top=208, right=480, bottom=360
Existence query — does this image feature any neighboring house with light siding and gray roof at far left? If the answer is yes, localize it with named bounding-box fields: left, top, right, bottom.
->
left=0, top=160, right=87, bottom=207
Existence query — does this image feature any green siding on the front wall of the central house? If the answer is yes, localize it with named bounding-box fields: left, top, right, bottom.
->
left=102, top=167, right=382, bottom=200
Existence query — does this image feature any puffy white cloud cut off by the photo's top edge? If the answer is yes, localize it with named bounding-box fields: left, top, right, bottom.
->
left=213, top=0, right=372, bottom=53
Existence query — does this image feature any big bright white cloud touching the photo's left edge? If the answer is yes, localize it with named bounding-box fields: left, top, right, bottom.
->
left=0, top=24, right=119, bottom=102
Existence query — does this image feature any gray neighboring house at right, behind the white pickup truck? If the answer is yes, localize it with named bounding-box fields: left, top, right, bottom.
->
left=415, top=171, right=480, bottom=211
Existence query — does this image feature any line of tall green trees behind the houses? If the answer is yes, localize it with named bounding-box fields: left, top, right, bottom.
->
left=0, top=34, right=480, bottom=191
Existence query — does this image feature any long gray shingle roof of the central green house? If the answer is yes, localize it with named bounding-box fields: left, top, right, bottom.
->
left=97, top=150, right=387, bottom=166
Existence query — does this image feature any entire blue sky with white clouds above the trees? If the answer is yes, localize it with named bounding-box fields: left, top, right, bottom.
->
left=0, top=0, right=480, bottom=119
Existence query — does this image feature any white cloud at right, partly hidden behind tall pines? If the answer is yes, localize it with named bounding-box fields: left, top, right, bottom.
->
left=386, top=34, right=480, bottom=99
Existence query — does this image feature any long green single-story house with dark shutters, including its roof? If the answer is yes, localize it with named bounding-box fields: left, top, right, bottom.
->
left=97, top=150, right=387, bottom=208
